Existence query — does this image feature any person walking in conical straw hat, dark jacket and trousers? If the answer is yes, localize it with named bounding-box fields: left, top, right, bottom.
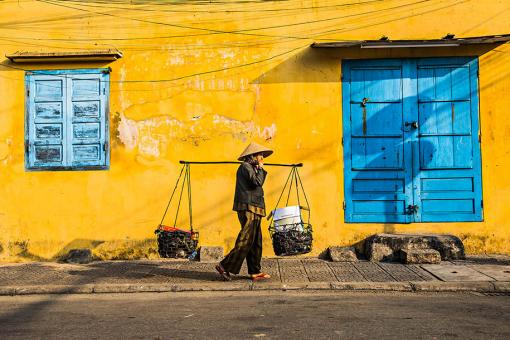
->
left=216, top=142, right=273, bottom=281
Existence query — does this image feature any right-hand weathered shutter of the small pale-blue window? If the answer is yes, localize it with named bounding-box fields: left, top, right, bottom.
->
left=67, top=74, right=108, bottom=168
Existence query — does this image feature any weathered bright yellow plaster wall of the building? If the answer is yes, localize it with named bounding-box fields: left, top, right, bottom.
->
left=0, top=0, right=510, bottom=261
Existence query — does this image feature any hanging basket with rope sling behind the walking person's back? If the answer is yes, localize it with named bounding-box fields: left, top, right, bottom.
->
left=154, top=164, right=198, bottom=258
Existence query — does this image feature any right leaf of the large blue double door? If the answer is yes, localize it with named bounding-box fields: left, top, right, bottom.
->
left=414, top=58, right=482, bottom=222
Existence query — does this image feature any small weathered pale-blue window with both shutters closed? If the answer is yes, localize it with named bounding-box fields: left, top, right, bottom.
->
left=25, top=69, right=109, bottom=170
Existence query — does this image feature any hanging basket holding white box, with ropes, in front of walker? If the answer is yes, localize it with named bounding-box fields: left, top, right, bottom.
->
left=268, top=167, right=313, bottom=256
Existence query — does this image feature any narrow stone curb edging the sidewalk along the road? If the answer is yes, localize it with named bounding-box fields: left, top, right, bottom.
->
left=0, top=281, right=510, bottom=296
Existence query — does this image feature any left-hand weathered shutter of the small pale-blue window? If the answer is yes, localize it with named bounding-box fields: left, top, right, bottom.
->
left=25, top=74, right=67, bottom=169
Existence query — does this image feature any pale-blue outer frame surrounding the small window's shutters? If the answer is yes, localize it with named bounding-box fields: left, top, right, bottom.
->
left=24, top=67, right=111, bottom=172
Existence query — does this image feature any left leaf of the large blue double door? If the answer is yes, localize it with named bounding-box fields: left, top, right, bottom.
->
left=343, top=61, right=411, bottom=223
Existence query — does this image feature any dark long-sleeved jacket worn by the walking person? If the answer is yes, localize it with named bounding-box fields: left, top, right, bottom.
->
left=234, top=162, right=267, bottom=210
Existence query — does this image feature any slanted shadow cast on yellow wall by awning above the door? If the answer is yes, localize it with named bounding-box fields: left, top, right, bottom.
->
left=251, top=43, right=504, bottom=84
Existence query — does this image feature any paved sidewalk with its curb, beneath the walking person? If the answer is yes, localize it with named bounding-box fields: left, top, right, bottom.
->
left=0, top=256, right=510, bottom=295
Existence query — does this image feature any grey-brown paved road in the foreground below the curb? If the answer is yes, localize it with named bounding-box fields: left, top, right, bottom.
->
left=0, top=291, right=510, bottom=339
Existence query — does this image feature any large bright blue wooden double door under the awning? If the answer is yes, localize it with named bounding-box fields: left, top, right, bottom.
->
left=342, top=58, right=483, bottom=223
